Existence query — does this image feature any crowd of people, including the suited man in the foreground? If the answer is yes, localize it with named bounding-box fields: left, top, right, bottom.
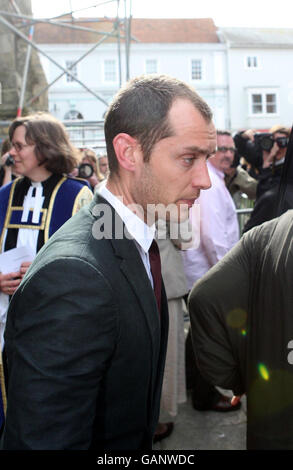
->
left=0, top=76, right=293, bottom=450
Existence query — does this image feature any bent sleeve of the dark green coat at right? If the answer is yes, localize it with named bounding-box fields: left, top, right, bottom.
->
left=189, top=235, right=250, bottom=395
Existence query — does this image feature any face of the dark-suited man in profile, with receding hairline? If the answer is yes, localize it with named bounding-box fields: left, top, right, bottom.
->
left=133, top=99, right=216, bottom=221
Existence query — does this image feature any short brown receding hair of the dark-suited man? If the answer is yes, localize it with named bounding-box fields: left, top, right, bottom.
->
left=105, top=75, right=212, bottom=174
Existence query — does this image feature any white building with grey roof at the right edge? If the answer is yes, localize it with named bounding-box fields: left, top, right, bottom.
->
left=220, top=28, right=293, bottom=131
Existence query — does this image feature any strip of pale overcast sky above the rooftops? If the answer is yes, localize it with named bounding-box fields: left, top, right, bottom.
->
left=32, top=0, right=293, bottom=28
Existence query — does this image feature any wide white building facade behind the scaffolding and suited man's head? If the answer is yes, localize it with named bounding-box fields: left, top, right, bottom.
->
left=38, top=20, right=229, bottom=139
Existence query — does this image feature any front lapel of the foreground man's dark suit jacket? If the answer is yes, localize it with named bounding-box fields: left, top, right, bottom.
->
left=90, top=194, right=169, bottom=433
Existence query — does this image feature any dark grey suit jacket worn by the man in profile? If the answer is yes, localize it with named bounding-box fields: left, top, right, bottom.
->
left=2, top=196, right=168, bottom=450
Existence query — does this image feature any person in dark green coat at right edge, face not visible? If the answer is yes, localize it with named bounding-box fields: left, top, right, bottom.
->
left=189, top=210, right=293, bottom=450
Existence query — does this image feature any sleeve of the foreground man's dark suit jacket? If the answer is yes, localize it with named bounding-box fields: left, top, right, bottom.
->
left=4, top=258, right=119, bottom=450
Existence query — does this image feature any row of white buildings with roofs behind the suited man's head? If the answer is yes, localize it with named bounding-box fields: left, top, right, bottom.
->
left=38, top=19, right=293, bottom=141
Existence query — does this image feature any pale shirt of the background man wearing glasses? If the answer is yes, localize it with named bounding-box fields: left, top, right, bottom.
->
left=181, top=162, right=239, bottom=290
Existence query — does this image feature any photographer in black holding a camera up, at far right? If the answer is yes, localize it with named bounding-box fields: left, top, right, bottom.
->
left=243, top=125, right=293, bottom=232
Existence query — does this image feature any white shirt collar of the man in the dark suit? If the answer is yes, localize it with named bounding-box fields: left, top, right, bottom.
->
left=98, top=183, right=155, bottom=253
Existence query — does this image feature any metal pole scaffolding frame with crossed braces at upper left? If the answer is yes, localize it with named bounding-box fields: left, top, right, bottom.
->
left=0, top=0, right=133, bottom=116
